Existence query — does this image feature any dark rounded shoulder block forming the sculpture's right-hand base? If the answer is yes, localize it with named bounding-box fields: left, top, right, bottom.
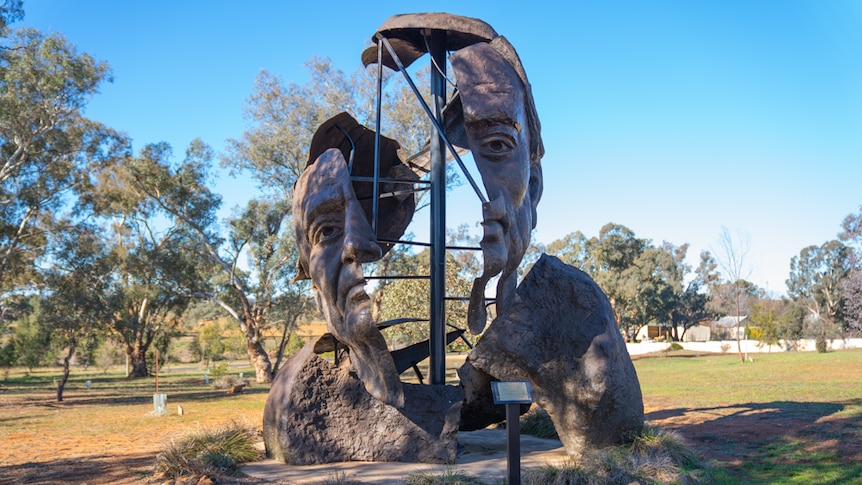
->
left=466, top=255, right=644, bottom=456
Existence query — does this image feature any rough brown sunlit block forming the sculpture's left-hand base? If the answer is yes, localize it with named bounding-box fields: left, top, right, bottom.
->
left=263, top=344, right=463, bottom=465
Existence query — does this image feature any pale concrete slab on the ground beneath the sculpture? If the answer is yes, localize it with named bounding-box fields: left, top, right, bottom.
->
left=241, top=429, right=567, bottom=485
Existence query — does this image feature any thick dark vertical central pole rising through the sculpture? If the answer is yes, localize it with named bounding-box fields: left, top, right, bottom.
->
left=429, top=30, right=446, bottom=385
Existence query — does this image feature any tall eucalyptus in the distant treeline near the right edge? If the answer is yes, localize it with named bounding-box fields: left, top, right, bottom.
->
left=787, top=240, right=852, bottom=352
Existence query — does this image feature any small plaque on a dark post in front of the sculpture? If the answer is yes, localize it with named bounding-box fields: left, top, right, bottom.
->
left=491, top=381, right=533, bottom=485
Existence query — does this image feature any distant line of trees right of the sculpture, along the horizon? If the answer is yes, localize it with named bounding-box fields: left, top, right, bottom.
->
left=534, top=217, right=862, bottom=350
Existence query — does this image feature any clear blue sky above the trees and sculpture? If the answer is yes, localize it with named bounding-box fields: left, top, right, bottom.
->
left=20, top=0, right=862, bottom=294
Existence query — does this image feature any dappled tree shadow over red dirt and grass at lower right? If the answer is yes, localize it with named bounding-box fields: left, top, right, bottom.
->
left=646, top=399, right=862, bottom=484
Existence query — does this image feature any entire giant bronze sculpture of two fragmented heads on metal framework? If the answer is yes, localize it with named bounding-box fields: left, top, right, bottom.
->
left=264, top=13, right=643, bottom=464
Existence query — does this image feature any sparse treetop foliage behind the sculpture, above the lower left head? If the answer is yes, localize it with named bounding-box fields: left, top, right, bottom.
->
left=221, top=57, right=430, bottom=194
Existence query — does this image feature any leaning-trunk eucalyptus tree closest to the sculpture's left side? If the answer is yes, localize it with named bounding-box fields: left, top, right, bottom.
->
left=120, top=140, right=309, bottom=382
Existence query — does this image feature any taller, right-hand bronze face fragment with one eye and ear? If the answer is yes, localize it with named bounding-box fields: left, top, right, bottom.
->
left=450, top=38, right=542, bottom=333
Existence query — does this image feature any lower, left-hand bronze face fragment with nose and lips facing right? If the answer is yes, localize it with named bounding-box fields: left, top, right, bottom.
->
left=293, top=149, right=404, bottom=407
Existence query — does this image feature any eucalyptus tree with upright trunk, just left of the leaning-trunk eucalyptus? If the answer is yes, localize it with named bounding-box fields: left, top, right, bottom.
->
left=84, top=144, right=211, bottom=377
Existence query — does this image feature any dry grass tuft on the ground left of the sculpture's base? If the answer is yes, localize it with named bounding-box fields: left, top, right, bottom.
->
left=155, top=422, right=261, bottom=478
